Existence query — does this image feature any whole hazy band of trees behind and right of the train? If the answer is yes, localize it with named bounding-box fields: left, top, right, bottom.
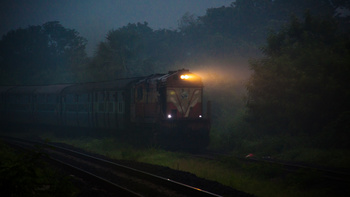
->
left=0, top=0, right=350, bottom=159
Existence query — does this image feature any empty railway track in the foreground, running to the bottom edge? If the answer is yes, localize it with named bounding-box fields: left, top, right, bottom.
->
left=3, top=137, right=220, bottom=196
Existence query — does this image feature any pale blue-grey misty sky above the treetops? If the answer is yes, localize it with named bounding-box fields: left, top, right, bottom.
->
left=0, top=0, right=234, bottom=55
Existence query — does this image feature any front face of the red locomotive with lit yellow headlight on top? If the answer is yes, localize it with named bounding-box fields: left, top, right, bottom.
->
left=157, top=69, right=210, bottom=150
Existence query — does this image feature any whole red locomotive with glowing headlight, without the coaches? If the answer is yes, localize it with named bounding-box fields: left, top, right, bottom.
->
left=132, top=69, right=210, bottom=150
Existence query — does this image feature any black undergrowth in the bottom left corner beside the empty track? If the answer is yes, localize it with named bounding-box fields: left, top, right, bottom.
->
left=0, top=141, right=79, bottom=196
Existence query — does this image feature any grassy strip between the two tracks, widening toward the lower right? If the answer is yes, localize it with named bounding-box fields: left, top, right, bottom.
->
left=1, top=130, right=348, bottom=197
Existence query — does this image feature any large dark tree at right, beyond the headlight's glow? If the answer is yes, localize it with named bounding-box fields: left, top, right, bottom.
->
left=247, top=13, right=350, bottom=145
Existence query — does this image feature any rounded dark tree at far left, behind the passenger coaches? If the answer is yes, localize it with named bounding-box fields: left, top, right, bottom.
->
left=0, top=21, right=87, bottom=84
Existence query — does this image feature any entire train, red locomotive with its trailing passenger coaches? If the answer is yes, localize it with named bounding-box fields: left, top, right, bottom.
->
left=0, top=69, right=210, bottom=150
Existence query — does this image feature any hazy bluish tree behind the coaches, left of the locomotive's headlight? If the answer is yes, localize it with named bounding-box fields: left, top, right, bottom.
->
left=90, top=22, right=157, bottom=80
